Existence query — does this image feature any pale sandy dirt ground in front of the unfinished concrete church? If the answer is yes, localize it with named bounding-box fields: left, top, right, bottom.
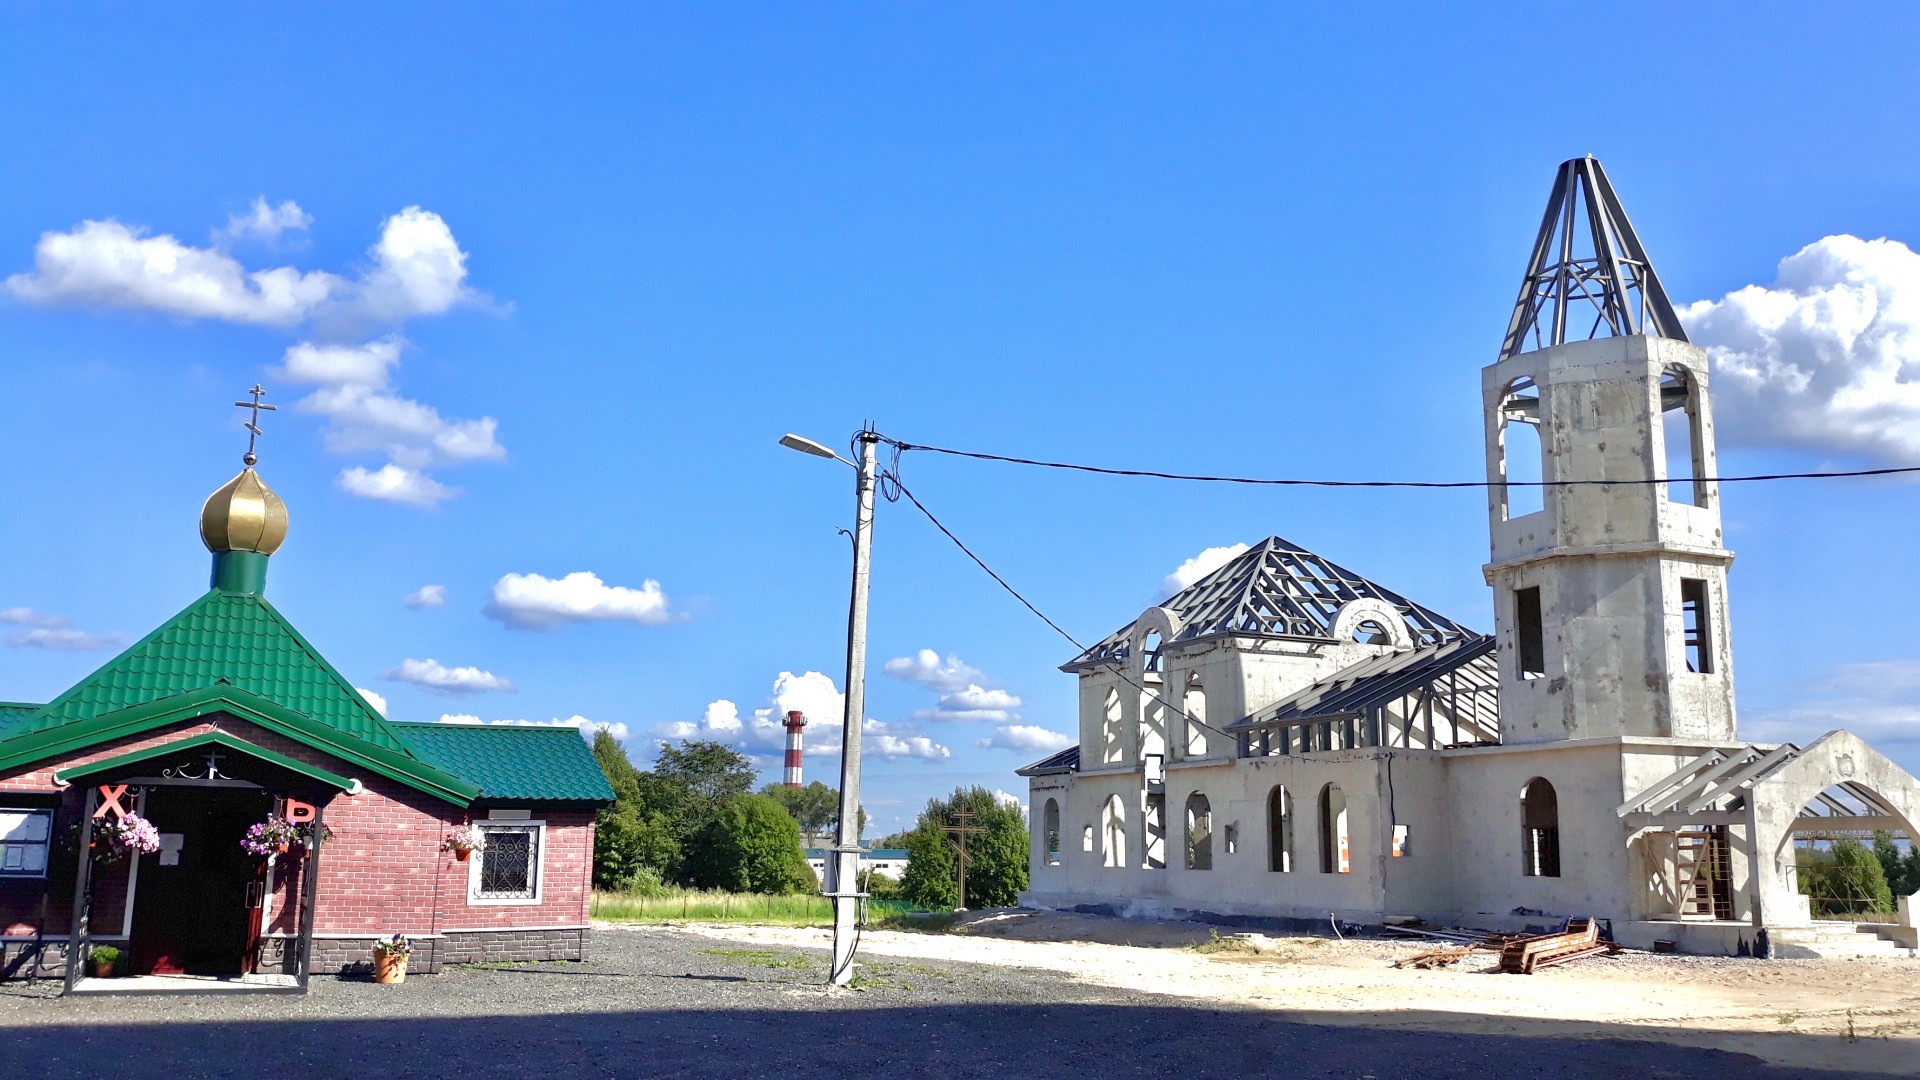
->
left=684, top=911, right=1920, bottom=1076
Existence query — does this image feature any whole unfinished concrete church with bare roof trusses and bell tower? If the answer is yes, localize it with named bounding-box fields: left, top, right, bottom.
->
left=1020, top=158, right=1920, bottom=955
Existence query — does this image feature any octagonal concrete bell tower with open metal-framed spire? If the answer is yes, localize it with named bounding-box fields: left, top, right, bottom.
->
left=1480, top=158, right=1734, bottom=746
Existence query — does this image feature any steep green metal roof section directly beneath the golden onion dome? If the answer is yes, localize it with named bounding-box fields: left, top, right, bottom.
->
left=0, top=590, right=413, bottom=757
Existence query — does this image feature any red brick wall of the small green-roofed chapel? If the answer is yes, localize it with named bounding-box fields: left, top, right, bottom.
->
left=0, top=715, right=593, bottom=934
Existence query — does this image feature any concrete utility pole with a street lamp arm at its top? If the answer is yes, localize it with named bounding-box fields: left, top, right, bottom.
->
left=780, top=429, right=879, bottom=986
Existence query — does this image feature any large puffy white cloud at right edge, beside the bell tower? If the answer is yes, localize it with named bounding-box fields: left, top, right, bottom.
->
left=1680, top=234, right=1920, bottom=465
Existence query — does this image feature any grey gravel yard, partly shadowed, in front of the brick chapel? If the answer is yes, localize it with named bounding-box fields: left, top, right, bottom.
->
left=0, top=914, right=1873, bottom=1080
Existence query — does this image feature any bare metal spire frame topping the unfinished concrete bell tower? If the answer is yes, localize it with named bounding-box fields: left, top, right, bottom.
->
left=1500, top=158, right=1688, bottom=359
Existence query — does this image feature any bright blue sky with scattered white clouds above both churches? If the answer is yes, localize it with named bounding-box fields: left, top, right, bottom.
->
left=0, top=4, right=1920, bottom=828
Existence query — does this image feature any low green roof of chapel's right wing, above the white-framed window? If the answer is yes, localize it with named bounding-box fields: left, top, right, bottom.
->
left=390, top=723, right=612, bottom=803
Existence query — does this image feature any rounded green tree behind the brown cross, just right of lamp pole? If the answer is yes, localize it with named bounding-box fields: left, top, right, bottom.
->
left=889, top=786, right=1027, bottom=911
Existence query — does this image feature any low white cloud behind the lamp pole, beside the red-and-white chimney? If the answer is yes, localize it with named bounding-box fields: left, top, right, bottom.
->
left=651, top=671, right=952, bottom=761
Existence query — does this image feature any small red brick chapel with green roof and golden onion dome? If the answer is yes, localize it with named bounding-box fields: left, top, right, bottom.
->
left=0, top=426, right=612, bottom=990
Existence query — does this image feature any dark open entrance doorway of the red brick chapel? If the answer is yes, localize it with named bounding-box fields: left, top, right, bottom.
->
left=131, top=788, right=273, bottom=974
